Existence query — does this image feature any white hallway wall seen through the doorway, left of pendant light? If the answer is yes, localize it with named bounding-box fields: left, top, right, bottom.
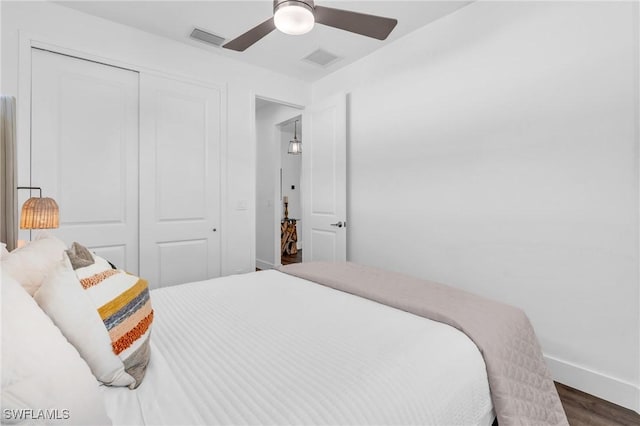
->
left=256, top=103, right=300, bottom=269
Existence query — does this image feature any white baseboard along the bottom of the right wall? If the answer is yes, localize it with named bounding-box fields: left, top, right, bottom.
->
left=544, top=355, right=640, bottom=413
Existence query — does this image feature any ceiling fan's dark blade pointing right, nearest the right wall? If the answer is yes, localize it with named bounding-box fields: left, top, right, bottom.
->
left=315, top=6, right=398, bottom=40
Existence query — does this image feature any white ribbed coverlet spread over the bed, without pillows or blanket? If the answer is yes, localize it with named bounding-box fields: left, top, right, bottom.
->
left=103, top=271, right=494, bottom=425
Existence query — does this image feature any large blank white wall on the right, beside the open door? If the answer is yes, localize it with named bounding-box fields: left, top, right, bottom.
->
left=313, top=1, right=640, bottom=411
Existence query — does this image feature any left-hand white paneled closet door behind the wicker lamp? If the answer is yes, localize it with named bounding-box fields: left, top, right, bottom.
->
left=31, top=49, right=139, bottom=273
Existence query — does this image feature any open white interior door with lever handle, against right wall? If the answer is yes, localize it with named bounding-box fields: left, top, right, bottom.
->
left=302, top=94, right=347, bottom=262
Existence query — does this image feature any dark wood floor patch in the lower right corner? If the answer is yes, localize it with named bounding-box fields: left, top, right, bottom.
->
left=556, top=383, right=640, bottom=426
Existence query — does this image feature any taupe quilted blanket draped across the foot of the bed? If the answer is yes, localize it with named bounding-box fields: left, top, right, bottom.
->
left=281, top=262, right=569, bottom=426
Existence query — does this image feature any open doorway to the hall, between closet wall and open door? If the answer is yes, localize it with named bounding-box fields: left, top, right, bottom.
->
left=255, top=97, right=303, bottom=270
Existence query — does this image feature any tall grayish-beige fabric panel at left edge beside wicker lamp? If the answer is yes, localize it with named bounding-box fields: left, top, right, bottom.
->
left=0, top=96, right=18, bottom=250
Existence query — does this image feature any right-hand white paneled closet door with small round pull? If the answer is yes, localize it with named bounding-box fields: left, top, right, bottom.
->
left=140, top=74, right=222, bottom=287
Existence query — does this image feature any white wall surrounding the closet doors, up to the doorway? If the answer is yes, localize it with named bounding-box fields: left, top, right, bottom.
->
left=0, top=1, right=310, bottom=274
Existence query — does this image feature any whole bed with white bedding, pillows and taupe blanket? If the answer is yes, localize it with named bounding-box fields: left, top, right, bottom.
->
left=2, top=237, right=567, bottom=426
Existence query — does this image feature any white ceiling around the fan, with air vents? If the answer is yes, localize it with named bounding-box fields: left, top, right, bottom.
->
left=57, top=0, right=470, bottom=81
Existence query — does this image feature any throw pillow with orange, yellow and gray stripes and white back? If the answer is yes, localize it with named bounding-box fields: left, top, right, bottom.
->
left=34, top=253, right=154, bottom=389
